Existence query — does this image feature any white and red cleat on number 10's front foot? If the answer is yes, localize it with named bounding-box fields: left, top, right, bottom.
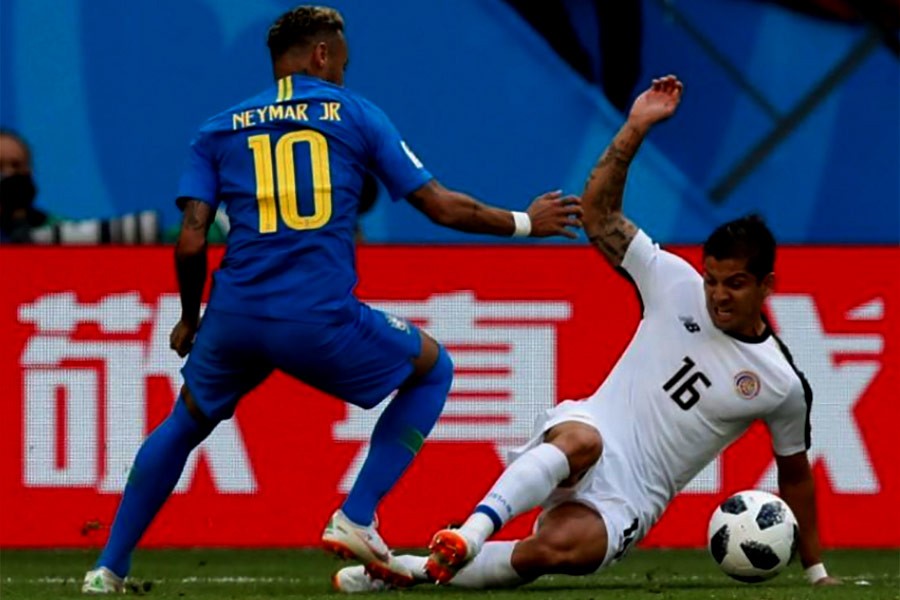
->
left=322, top=510, right=413, bottom=587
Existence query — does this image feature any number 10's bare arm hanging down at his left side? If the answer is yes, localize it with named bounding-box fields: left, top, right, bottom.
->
left=169, top=198, right=215, bottom=357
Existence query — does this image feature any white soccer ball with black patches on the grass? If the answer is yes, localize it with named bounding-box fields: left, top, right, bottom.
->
left=707, top=490, right=800, bottom=583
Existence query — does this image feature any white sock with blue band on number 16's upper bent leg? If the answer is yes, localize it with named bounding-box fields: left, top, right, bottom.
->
left=454, top=443, right=569, bottom=548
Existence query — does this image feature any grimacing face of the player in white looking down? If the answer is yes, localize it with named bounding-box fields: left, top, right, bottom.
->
left=703, top=256, right=774, bottom=336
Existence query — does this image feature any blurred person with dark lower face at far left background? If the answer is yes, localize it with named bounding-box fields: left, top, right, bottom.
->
left=0, top=128, right=50, bottom=244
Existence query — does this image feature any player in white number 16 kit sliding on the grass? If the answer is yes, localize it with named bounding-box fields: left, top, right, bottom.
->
left=334, top=76, right=840, bottom=592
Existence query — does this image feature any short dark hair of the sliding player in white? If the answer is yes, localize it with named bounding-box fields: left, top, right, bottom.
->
left=703, top=215, right=775, bottom=281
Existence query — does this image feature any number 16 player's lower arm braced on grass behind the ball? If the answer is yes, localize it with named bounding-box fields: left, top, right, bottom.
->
left=775, top=452, right=840, bottom=585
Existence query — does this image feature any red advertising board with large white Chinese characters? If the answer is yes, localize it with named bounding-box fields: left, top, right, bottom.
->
left=0, top=247, right=900, bottom=548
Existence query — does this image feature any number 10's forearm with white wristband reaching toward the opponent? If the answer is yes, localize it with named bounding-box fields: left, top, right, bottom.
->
left=407, top=179, right=581, bottom=239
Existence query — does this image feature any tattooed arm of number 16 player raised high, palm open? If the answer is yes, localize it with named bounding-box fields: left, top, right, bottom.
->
left=581, top=75, right=683, bottom=267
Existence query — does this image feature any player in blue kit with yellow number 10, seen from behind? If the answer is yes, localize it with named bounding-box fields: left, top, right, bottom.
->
left=82, top=6, right=581, bottom=593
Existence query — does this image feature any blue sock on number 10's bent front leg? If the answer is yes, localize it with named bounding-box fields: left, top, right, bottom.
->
left=341, top=346, right=453, bottom=525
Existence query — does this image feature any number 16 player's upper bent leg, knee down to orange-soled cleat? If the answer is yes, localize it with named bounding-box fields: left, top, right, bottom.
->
left=426, top=421, right=603, bottom=583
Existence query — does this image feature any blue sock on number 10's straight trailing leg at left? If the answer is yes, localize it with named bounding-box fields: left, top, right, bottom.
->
left=94, top=395, right=212, bottom=577
